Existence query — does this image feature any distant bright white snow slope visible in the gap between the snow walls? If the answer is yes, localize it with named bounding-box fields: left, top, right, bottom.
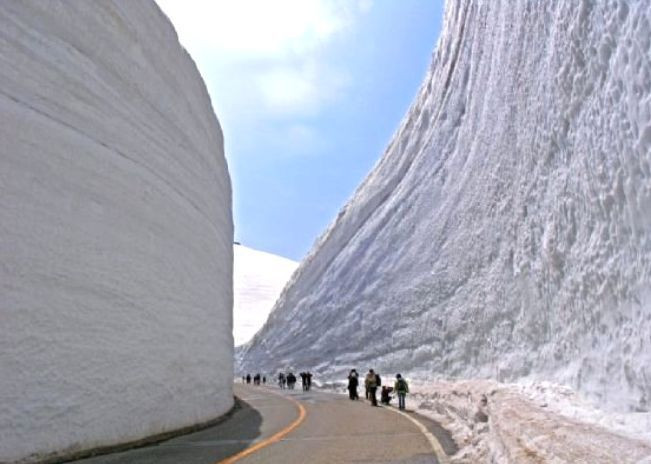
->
left=233, top=245, right=298, bottom=346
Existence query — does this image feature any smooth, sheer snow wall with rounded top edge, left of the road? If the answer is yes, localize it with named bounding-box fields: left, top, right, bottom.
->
left=0, top=0, right=233, bottom=462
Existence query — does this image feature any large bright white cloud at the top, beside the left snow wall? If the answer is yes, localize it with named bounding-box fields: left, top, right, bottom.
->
left=157, top=0, right=372, bottom=154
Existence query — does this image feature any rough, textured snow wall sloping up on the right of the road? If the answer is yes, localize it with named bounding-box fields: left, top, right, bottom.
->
left=237, top=0, right=651, bottom=410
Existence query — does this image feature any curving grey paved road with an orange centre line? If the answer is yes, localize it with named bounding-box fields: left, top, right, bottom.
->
left=79, top=385, right=455, bottom=464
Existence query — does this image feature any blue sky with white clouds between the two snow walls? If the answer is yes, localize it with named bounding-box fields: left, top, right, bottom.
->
left=157, top=0, right=443, bottom=260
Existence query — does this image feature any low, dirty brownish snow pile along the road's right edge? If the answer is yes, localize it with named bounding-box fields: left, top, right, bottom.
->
left=407, top=380, right=651, bottom=464
